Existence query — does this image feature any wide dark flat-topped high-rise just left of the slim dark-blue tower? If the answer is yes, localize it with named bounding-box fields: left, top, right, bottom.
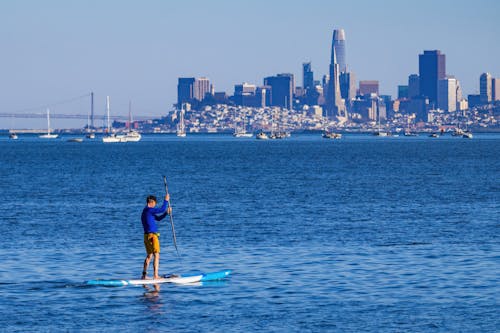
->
left=264, top=74, right=295, bottom=109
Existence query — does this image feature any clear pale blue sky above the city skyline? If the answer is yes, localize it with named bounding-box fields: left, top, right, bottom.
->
left=0, top=0, right=500, bottom=128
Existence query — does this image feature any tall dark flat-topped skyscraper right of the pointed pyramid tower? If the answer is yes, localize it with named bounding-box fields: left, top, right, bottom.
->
left=418, top=50, right=446, bottom=105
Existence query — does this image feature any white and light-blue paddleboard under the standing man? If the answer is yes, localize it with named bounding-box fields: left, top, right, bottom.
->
left=85, top=270, right=231, bottom=287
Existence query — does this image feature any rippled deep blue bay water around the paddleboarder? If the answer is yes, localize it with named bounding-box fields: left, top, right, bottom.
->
left=0, top=134, right=500, bottom=332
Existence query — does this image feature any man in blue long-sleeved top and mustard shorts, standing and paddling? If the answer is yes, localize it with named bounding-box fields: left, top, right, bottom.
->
left=141, top=193, right=172, bottom=279
